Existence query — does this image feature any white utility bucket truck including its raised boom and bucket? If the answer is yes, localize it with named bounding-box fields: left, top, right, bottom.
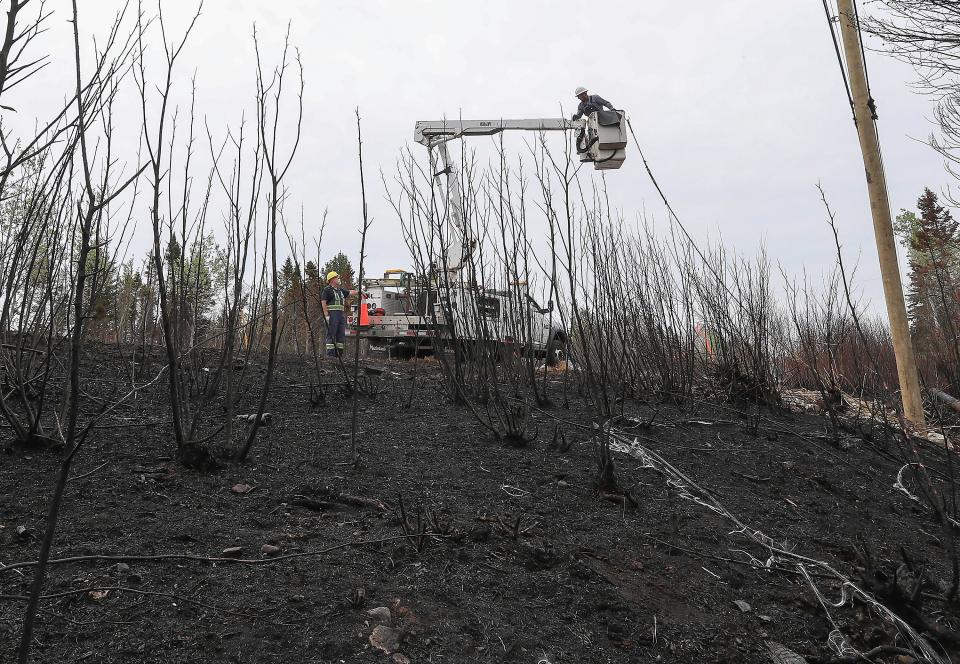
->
left=347, top=111, right=627, bottom=363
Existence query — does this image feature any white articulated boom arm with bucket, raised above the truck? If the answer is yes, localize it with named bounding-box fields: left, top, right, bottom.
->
left=413, top=111, right=627, bottom=272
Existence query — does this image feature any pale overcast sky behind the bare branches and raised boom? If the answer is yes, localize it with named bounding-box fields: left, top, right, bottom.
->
left=6, top=0, right=949, bottom=312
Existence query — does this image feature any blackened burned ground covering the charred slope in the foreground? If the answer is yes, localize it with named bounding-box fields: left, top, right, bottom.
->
left=0, top=351, right=948, bottom=664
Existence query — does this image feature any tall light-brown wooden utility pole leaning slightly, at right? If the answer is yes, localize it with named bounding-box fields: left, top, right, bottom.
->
left=837, top=0, right=926, bottom=431
